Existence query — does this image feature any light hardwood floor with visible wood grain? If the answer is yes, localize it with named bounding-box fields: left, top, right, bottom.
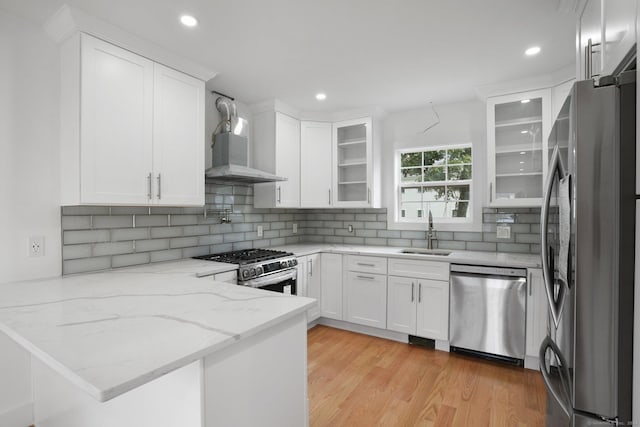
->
left=308, top=326, right=546, bottom=427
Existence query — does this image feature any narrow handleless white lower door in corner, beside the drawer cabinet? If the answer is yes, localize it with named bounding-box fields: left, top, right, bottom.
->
left=320, top=253, right=342, bottom=320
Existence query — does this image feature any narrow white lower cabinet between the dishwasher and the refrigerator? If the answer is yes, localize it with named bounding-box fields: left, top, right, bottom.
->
left=525, top=268, right=549, bottom=369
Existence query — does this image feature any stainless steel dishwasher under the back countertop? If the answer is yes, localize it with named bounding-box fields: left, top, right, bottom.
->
left=449, top=264, right=527, bottom=364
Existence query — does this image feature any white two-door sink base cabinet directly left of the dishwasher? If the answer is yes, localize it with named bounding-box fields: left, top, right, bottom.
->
left=387, top=259, right=449, bottom=341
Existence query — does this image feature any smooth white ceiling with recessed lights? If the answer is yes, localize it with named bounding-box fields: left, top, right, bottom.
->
left=0, top=0, right=575, bottom=111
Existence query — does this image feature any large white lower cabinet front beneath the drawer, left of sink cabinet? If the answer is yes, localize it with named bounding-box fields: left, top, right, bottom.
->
left=344, top=271, right=387, bottom=329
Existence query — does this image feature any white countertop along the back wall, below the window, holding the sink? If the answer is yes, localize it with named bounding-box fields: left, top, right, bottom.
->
left=271, top=243, right=542, bottom=268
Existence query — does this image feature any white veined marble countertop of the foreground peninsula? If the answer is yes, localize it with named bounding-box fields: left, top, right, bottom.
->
left=0, top=260, right=315, bottom=401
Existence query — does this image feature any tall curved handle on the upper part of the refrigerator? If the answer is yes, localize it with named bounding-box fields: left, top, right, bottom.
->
left=540, top=146, right=570, bottom=328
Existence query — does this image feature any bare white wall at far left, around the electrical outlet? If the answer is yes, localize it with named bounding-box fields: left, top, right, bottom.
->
left=0, top=10, right=61, bottom=427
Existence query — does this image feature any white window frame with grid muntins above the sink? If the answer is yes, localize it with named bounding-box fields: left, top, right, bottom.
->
left=393, top=142, right=475, bottom=225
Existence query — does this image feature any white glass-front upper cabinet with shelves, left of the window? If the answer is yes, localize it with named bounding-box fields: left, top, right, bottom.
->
left=333, top=117, right=375, bottom=207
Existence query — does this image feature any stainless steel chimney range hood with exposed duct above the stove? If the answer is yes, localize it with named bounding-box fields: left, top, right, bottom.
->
left=205, top=92, right=287, bottom=184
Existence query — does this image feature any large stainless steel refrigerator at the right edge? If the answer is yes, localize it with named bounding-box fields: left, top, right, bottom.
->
left=540, top=70, right=640, bottom=427
